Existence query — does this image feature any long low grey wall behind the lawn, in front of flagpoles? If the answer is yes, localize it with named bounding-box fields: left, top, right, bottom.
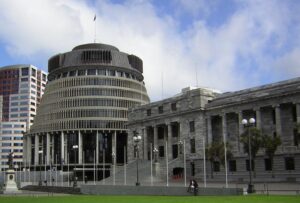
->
left=80, top=185, right=243, bottom=196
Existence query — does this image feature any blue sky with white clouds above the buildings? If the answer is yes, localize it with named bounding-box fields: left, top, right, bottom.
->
left=0, top=0, right=300, bottom=101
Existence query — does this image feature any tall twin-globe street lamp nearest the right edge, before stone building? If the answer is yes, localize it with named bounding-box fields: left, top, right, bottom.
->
left=242, top=118, right=255, bottom=193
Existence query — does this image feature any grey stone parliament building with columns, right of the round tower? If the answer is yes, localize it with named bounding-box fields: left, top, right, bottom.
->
left=128, top=78, right=300, bottom=181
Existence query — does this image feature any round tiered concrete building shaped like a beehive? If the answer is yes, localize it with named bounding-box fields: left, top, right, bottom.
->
left=24, top=43, right=149, bottom=178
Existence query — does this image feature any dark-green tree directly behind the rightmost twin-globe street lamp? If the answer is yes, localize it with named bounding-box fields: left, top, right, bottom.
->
left=241, top=127, right=263, bottom=170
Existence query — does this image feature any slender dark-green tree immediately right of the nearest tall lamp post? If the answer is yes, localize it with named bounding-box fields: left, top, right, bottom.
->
left=263, top=135, right=281, bottom=178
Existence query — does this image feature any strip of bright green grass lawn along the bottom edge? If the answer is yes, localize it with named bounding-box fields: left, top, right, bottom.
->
left=0, top=195, right=300, bottom=203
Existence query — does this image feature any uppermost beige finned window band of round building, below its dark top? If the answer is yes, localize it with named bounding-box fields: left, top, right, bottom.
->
left=47, top=77, right=146, bottom=92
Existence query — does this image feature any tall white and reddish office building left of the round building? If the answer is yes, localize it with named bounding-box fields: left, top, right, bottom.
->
left=0, top=64, right=47, bottom=170
